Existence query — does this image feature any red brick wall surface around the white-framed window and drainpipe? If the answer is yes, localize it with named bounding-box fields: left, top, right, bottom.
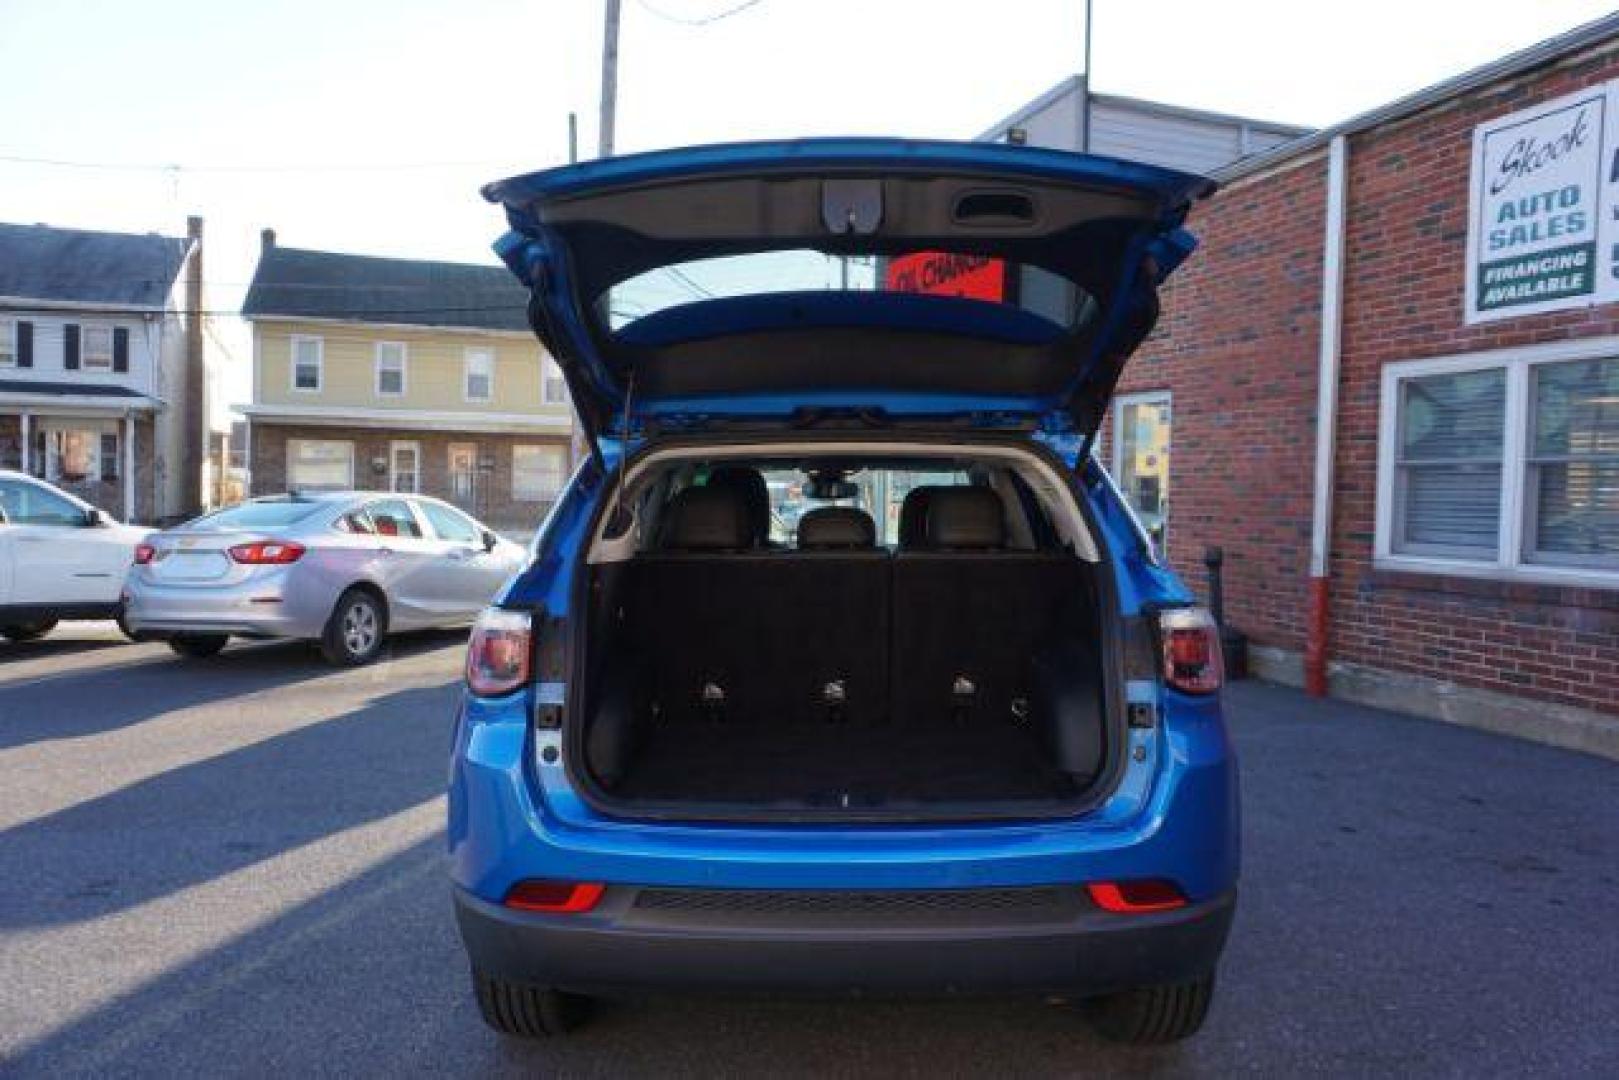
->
left=1120, top=40, right=1619, bottom=712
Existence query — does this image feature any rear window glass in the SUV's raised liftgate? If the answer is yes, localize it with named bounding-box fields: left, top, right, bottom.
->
left=599, top=248, right=1096, bottom=330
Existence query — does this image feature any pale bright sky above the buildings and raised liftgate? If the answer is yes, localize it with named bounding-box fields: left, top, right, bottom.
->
left=0, top=0, right=1609, bottom=420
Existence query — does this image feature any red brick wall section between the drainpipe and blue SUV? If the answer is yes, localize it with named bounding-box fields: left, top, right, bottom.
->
left=1104, top=155, right=1326, bottom=649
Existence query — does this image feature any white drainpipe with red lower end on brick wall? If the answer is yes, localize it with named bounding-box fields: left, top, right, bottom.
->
left=1305, top=134, right=1349, bottom=698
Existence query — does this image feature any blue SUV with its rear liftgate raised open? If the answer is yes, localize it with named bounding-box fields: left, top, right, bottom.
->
left=448, top=139, right=1239, bottom=1041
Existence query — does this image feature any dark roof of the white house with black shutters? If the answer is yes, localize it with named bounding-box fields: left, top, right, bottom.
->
left=0, top=223, right=191, bottom=309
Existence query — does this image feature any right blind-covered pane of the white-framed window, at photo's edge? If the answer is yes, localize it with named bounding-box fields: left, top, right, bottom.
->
left=1523, top=359, right=1619, bottom=568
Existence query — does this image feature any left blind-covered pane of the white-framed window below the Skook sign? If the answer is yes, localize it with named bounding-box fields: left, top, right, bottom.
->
left=1394, top=368, right=1507, bottom=557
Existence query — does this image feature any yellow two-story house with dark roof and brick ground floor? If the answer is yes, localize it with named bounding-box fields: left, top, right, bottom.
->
left=238, top=230, right=573, bottom=529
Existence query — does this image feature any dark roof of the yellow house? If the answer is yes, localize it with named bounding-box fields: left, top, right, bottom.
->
left=241, top=244, right=528, bottom=330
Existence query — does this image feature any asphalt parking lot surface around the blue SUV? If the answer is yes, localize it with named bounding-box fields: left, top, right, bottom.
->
left=0, top=625, right=1619, bottom=1075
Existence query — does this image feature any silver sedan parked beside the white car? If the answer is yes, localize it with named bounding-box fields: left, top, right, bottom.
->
left=125, top=492, right=528, bottom=664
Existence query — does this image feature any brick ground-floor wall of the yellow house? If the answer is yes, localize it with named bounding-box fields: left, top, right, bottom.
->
left=251, top=421, right=568, bottom=531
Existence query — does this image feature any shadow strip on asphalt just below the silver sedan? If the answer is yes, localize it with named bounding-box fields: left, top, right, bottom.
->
left=0, top=630, right=466, bottom=750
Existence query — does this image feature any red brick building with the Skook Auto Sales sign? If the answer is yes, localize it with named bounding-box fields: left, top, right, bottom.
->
left=1101, top=18, right=1619, bottom=756
